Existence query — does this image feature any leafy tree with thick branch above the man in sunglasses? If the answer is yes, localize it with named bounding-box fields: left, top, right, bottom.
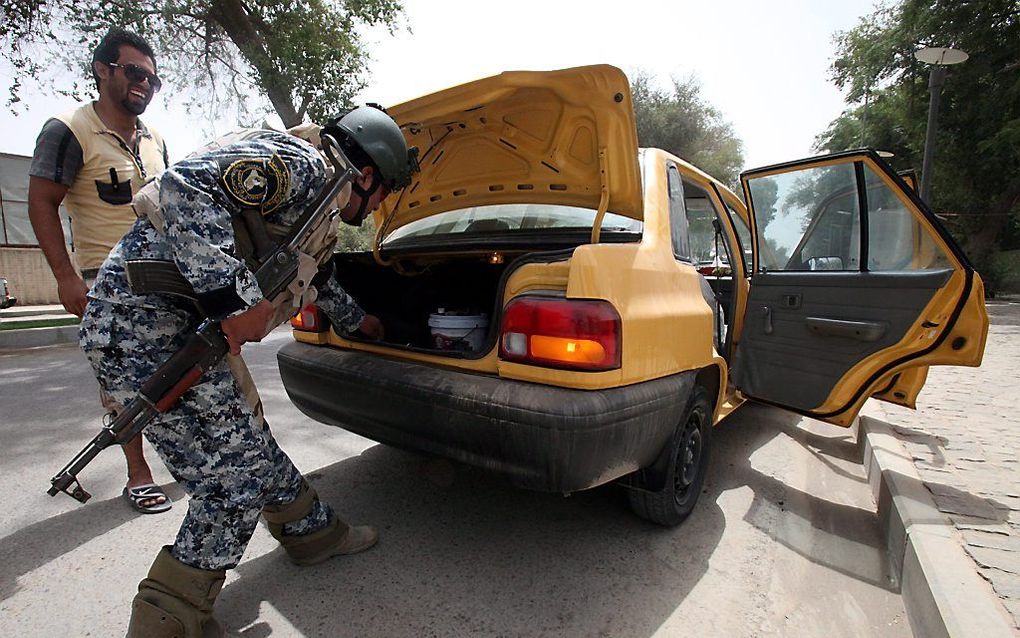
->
left=0, top=0, right=403, bottom=127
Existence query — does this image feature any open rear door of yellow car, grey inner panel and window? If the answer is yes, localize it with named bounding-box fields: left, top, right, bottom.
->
left=731, top=151, right=988, bottom=426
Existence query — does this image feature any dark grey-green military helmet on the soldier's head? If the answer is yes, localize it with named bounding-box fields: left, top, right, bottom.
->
left=325, top=104, right=418, bottom=191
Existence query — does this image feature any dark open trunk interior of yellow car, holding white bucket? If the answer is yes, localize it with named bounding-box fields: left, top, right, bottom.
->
left=333, top=217, right=642, bottom=358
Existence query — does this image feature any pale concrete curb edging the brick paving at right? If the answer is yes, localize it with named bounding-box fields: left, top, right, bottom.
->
left=857, top=416, right=1016, bottom=638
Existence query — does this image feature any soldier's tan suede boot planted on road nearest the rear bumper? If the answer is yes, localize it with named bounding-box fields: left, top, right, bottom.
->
left=262, top=480, right=378, bottom=566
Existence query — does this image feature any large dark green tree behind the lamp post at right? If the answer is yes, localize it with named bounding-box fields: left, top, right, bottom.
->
left=815, top=0, right=1020, bottom=281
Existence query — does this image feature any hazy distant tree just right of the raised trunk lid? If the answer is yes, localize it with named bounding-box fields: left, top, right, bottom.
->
left=630, top=70, right=744, bottom=186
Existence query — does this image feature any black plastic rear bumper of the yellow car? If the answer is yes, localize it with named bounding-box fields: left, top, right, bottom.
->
left=277, top=342, right=695, bottom=492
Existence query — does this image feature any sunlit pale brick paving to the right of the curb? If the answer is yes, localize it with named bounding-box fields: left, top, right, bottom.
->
left=867, top=302, right=1020, bottom=628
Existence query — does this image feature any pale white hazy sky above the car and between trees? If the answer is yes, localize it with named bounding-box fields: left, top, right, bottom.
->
left=0, top=0, right=874, bottom=167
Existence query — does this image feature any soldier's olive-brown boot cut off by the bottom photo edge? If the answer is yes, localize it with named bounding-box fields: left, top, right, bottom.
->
left=128, top=545, right=226, bottom=638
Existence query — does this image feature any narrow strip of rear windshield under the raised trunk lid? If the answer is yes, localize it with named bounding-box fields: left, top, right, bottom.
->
left=383, top=204, right=643, bottom=246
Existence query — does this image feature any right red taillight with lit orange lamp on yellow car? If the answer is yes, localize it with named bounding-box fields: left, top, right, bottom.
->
left=500, top=296, right=620, bottom=371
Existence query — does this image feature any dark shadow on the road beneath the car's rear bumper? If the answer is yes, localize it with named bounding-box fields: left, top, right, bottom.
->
left=218, top=445, right=725, bottom=638
